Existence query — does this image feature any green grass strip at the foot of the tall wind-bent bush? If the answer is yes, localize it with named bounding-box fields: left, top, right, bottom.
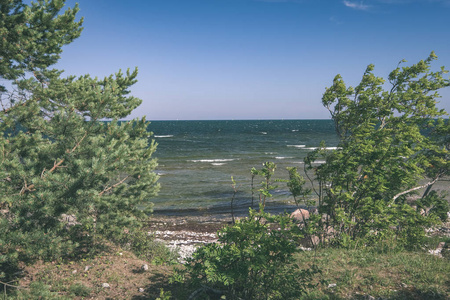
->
left=297, top=248, right=450, bottom=299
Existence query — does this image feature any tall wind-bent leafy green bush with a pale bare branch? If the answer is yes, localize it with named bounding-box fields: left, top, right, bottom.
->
left=305, top=52, right=450, bottom=248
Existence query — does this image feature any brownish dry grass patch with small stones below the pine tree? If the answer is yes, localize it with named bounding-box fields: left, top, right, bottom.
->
left=12, top=248, right=172, bottom=299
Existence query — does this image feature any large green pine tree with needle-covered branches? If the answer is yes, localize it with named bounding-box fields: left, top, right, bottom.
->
left=0, top=0, right=159, bottom=264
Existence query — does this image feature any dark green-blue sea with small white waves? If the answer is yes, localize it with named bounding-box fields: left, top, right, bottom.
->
left=149, top=120, right=338, bottom=216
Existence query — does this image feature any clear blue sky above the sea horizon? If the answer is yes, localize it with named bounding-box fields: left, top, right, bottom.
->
left=57, top=0, right=450, bottom=120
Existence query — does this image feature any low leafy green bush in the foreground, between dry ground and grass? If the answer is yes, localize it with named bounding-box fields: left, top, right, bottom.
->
left=180, top=209, right=318, bottom=299
